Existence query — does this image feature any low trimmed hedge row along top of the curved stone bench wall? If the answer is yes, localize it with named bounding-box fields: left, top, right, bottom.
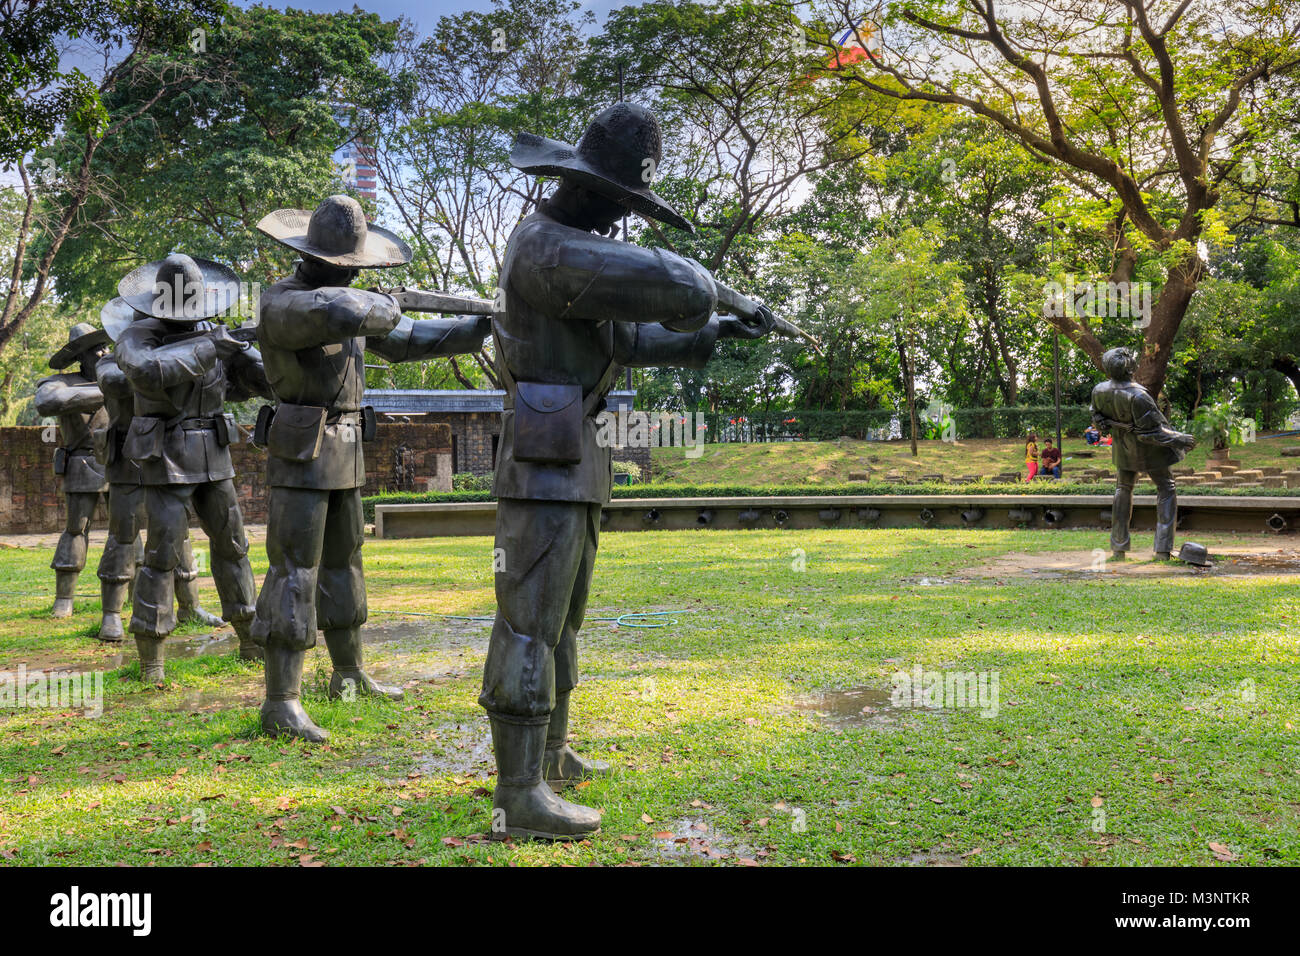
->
left=361, top=481, right=1300, bottom=522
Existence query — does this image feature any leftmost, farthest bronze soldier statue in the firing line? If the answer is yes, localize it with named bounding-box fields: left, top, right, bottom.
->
left=36, top=323, right=108, bottom=618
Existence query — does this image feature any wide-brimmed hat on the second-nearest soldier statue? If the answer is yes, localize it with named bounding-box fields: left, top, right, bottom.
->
left=257, top=195, right=411, bottom=269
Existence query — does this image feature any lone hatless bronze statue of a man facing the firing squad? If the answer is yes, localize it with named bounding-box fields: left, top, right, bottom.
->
left=1092, top=349, right=1196, bottom=561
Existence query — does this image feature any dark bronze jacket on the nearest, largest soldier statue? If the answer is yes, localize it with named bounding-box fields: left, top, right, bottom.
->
left=493, top=212, right=718, bottom=503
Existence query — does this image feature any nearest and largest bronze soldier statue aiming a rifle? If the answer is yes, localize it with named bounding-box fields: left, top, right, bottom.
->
left=478, top=103, right=776, bottom=839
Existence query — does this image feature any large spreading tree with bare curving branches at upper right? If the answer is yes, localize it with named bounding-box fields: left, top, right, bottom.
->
left=815, top=0, right=1300, bottom=390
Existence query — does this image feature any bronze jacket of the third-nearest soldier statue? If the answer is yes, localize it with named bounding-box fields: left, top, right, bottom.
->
left=114, top=319, right=270, bottom=485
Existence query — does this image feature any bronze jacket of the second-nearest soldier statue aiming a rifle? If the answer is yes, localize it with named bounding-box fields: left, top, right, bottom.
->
left=257, top=271, right=482, bottom=489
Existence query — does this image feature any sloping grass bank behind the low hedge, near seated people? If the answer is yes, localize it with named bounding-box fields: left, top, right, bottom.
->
left=651, top=436, right=1300, bottom=485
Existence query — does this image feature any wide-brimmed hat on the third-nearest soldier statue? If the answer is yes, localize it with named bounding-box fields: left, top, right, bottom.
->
left=117, top=252, right=239, bottom=323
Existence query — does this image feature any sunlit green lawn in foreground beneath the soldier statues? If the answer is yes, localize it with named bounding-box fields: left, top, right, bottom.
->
left=0, top=528, right=1300, bottom=866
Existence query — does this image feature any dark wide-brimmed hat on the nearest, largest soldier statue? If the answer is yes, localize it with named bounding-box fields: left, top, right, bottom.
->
left=510, top=103, right=696, bottom=233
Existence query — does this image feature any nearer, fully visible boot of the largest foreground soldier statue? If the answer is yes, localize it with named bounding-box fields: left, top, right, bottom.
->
left=490, top=714, right=601, bottom=840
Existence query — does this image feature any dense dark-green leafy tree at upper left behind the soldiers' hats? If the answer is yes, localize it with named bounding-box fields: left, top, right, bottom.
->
left=52, top=7, right=407, bottom=306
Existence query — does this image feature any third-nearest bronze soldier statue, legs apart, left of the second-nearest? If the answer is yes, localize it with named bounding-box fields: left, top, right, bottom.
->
left=116, top=255, right=270, bottom=682
